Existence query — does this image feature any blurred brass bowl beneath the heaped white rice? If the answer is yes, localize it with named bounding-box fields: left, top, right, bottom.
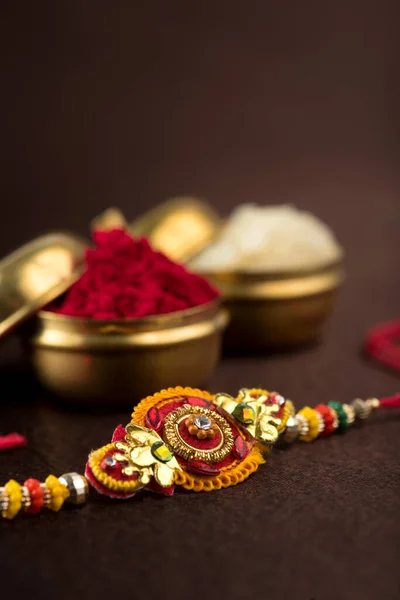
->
left=206, top=262, right=344, bottom=353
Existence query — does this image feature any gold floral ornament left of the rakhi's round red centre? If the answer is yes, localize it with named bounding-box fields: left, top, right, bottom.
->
left=113, top=423, right=181, bottom=488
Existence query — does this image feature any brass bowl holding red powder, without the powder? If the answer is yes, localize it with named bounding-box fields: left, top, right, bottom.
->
left=27, top=302, right=228, bottom=406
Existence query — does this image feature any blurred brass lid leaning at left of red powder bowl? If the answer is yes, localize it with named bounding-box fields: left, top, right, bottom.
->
left=0, top=233, right=87, bottom=338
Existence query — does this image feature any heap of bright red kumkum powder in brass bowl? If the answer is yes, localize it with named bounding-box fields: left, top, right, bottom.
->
left=53, top=229, right=219, bottom=319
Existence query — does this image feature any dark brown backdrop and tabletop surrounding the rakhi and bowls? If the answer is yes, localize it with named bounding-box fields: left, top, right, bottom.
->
left=0, top=0, right=400, bottom=600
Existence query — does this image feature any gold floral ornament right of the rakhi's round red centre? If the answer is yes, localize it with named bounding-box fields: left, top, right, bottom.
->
left=213, top=388, right=281, bottom=444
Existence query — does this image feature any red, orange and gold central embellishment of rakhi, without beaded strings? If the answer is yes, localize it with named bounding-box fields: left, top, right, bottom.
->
left=86, top=387, right=291, bottom=498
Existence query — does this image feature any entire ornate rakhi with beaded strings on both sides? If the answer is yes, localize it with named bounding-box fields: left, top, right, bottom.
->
left=0, top=387, right=400, bottom=519
